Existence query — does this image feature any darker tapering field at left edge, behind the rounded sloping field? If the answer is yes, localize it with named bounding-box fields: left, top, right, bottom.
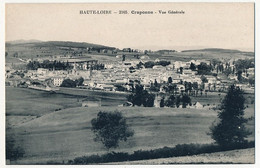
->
left=6, top=87, right=82, bottom=116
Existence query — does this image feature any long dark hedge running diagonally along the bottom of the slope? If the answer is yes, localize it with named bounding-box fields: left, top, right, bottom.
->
left=68, top=141, right=255, bottom=164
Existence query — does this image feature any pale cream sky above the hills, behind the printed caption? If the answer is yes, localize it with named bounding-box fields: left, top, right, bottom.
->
left=5, top=3, right=254, bottom=51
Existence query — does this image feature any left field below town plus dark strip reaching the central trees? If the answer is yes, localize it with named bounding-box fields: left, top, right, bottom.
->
left=6, top=87, right=126, bottom=116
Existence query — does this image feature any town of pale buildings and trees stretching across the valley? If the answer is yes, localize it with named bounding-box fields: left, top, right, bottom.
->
left=6, top=42, right=254, bottom=107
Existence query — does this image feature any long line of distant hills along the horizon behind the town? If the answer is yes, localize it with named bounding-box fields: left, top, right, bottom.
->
left=6, top=40, right=255, bottom=63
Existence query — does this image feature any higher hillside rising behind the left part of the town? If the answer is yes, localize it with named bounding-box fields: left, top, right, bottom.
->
left=5, top=40, right=115, bottom=63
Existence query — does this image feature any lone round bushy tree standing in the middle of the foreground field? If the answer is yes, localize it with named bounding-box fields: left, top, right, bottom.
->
left=91, top=111, right=134, bottom=150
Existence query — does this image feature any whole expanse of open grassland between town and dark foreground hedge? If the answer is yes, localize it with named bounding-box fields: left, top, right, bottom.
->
left=6, top=87, right=254, bottom=164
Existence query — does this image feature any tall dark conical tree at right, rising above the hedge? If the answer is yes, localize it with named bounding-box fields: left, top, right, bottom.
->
left=210, top=85, right=251, bottom=149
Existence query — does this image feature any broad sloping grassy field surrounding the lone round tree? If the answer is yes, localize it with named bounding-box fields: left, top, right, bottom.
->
left=9, top=107, right=254, bottom=164
